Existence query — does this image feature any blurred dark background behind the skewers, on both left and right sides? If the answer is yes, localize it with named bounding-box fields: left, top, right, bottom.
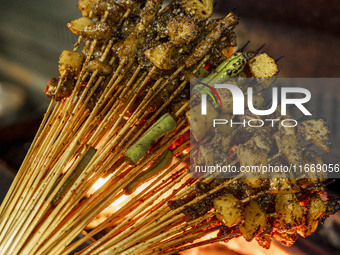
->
left=0, top=0, right=340, bottom=253
